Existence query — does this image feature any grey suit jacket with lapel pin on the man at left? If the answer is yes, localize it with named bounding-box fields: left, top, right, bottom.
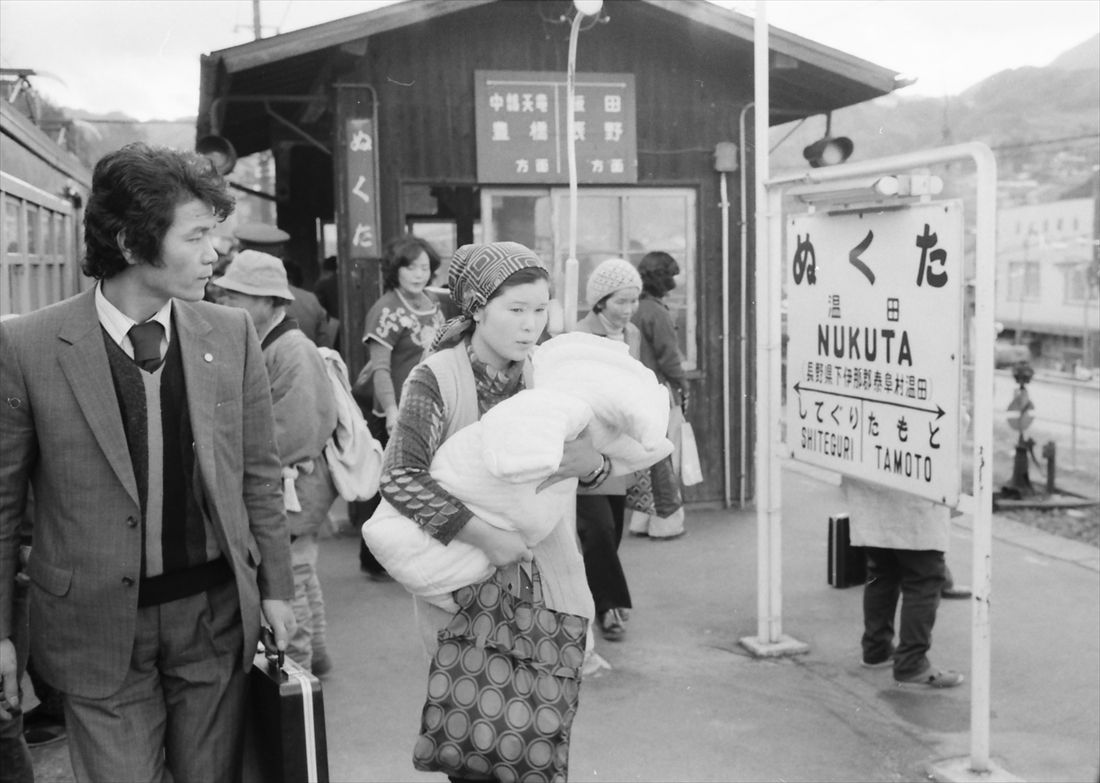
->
left=0, top=290, right=294, bottom=698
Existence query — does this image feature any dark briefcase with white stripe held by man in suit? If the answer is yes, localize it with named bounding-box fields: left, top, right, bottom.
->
left=243, top=629, right=329, bottom=783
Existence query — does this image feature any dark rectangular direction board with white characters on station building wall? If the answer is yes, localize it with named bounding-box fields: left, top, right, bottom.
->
left=474, top=70, right=638, bottom=185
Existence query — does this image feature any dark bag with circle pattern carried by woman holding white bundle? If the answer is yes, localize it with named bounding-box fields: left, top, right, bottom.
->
left=413, top=563, right=589, bottom=783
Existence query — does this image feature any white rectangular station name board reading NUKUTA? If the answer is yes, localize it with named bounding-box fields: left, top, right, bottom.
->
left=787, top=201, right=963, bottom=506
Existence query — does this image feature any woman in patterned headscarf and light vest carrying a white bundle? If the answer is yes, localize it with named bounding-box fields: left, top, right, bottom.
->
left=381, top=242, right=611, bottom=780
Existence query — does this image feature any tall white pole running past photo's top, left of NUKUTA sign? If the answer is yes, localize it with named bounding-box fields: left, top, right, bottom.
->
left=752, top=0, right=782, bottom=643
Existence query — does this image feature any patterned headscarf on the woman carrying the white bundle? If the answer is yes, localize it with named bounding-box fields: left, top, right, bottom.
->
left=431, top=242, right=546, bottom=352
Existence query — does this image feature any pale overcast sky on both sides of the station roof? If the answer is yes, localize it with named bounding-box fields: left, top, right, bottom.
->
left=0, top=0, right=1100, bottom=120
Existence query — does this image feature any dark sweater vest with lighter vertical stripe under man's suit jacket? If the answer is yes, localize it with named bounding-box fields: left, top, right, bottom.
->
left=103, top=331, right=226, bottom=606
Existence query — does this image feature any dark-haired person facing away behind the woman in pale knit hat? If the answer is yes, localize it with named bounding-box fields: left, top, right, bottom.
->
left=627, top=251, right=688, bottom=540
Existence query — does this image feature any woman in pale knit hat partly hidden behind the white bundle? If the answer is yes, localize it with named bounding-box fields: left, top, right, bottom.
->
left=576, top=258, right=641, bottom=641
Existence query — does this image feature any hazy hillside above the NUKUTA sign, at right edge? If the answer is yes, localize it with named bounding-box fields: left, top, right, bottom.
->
left=771, top=35, right=1100, bottom=200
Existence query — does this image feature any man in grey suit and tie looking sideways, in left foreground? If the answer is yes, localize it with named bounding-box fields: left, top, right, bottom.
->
left=0, top=144, right=294, bottom=783
